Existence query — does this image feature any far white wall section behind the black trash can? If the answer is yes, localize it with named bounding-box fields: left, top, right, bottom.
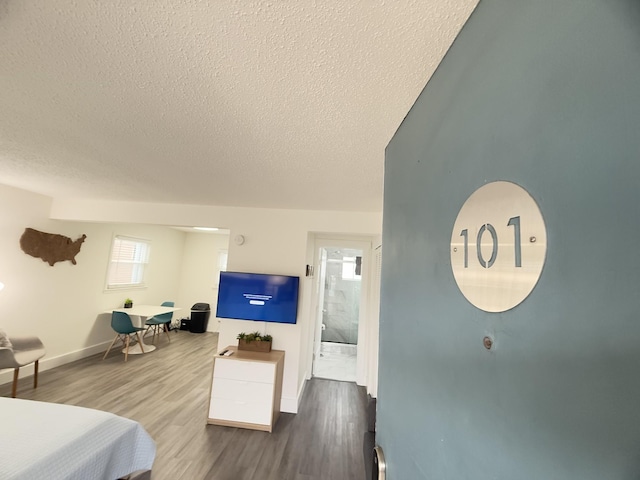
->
left=178, top=232, right=229, bottom=332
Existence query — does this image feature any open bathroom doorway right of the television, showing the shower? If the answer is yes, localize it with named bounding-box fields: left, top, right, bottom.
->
left=313, top=245, right=363, bottom=382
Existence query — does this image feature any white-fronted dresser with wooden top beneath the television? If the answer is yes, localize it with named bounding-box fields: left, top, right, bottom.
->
left=207, top=346, right=284, bottom=432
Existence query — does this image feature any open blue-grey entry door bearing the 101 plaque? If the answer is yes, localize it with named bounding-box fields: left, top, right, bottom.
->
left=377, top=0, right=640, bottom=480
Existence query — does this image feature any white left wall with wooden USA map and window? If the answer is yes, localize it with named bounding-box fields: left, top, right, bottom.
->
left=0, top=185, right=190, bottom=383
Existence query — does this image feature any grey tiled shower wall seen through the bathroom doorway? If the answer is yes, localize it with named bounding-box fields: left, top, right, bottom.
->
left=322, top=262, right=361, bottom=345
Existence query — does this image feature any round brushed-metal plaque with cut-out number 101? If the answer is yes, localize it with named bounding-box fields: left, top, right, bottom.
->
left=451, top=182, right=547, bottom=312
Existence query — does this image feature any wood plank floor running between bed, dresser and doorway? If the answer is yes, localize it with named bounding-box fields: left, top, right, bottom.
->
left=0, top=331, right=367, bottom=480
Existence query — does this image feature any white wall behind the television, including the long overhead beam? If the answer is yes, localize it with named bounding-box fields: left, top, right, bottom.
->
left=51, top=195, right=382, bottom=413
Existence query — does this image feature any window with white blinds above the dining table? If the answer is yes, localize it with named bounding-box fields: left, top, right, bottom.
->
left=107, top=235, right=151, bottom=290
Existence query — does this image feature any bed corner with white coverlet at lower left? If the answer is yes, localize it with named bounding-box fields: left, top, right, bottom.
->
left=0, top=397, right=156, bottom=480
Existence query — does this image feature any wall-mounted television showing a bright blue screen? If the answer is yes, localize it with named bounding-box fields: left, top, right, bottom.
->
left=216, top=272, right=300, bottom=323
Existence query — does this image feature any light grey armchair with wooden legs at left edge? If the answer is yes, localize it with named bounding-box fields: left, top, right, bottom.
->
left=0, top=330, right=46, bottom=398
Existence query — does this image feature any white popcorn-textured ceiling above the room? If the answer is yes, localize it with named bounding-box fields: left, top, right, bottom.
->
left=0, top=0, right=477, bottom=211
